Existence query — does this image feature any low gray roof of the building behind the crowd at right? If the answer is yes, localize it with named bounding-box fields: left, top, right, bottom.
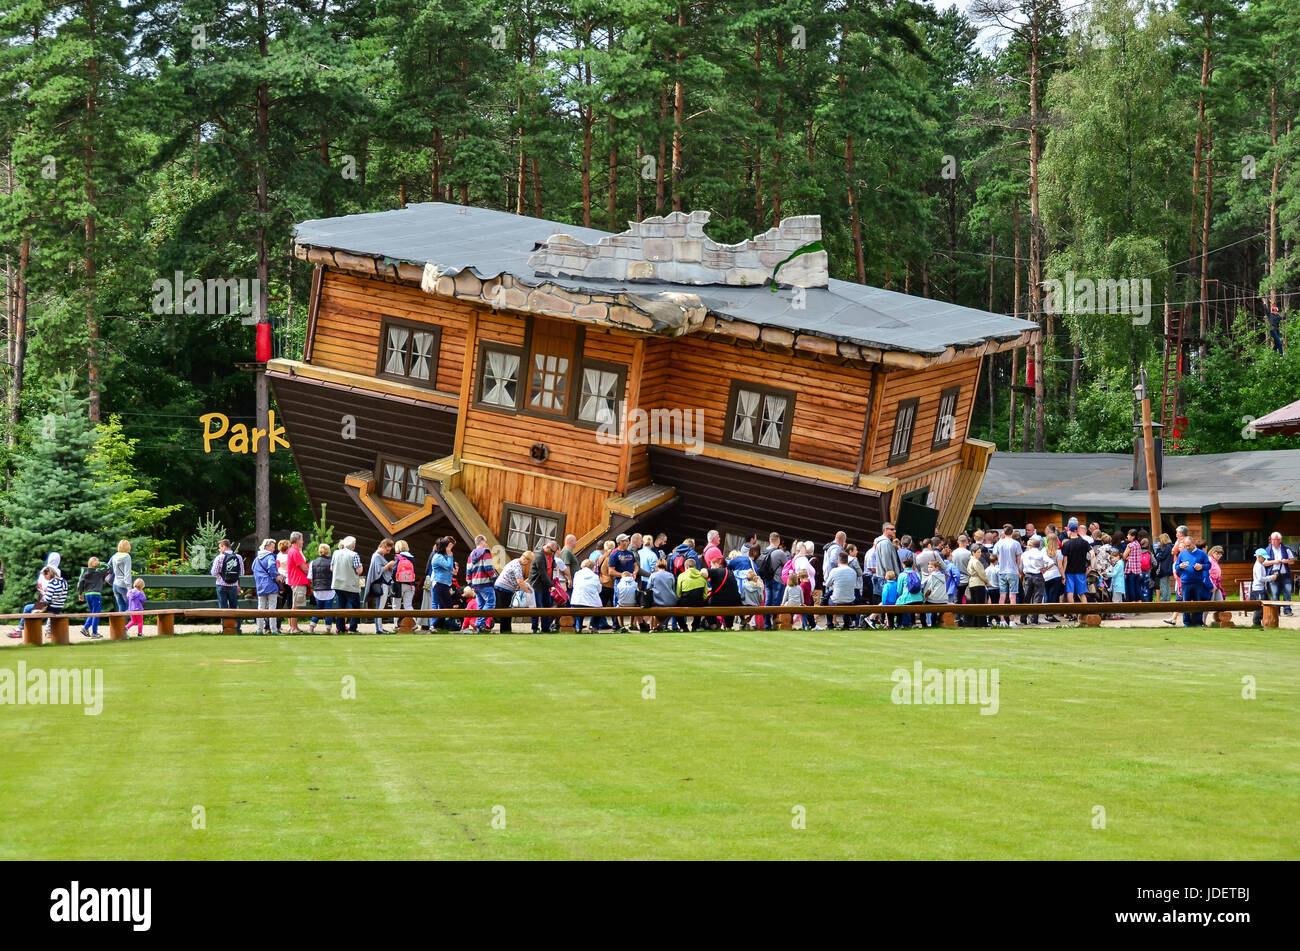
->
left=975, top=450, right=1300, bottom=513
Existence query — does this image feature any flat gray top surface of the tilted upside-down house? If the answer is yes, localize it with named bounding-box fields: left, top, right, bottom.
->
left=294, top=203, right=1037, bottom=355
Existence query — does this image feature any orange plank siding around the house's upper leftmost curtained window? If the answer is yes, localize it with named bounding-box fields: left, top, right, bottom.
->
left=312, top=270, right=471, bottom=392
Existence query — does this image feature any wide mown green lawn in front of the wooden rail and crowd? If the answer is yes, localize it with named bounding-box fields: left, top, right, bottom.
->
left=0, top=628, right=1300, bottom=859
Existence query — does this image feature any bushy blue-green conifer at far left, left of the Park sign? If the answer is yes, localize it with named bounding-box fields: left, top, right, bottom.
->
left=0, top=382, right=129, bottom=611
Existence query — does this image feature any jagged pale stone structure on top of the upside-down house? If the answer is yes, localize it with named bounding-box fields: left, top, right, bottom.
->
left=528, top=212, right=829, bottom=287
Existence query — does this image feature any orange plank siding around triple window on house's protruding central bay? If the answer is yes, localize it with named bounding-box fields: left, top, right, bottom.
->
left=462, top=313, right=633, bottom=491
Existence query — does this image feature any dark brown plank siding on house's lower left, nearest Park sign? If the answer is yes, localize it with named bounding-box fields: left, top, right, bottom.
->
left=270, top=377, right=456, bottom=556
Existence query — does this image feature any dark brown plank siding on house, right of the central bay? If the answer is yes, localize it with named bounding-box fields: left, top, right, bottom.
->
left=647, top=447, right=884, bottom=551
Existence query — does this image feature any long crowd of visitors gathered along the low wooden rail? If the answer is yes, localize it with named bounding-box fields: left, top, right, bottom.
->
left=9, top=518, right=1295, bottom=638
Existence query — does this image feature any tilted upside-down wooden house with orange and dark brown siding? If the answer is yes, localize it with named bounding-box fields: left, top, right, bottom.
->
left=265, top=203, right=1037, bottom=552
